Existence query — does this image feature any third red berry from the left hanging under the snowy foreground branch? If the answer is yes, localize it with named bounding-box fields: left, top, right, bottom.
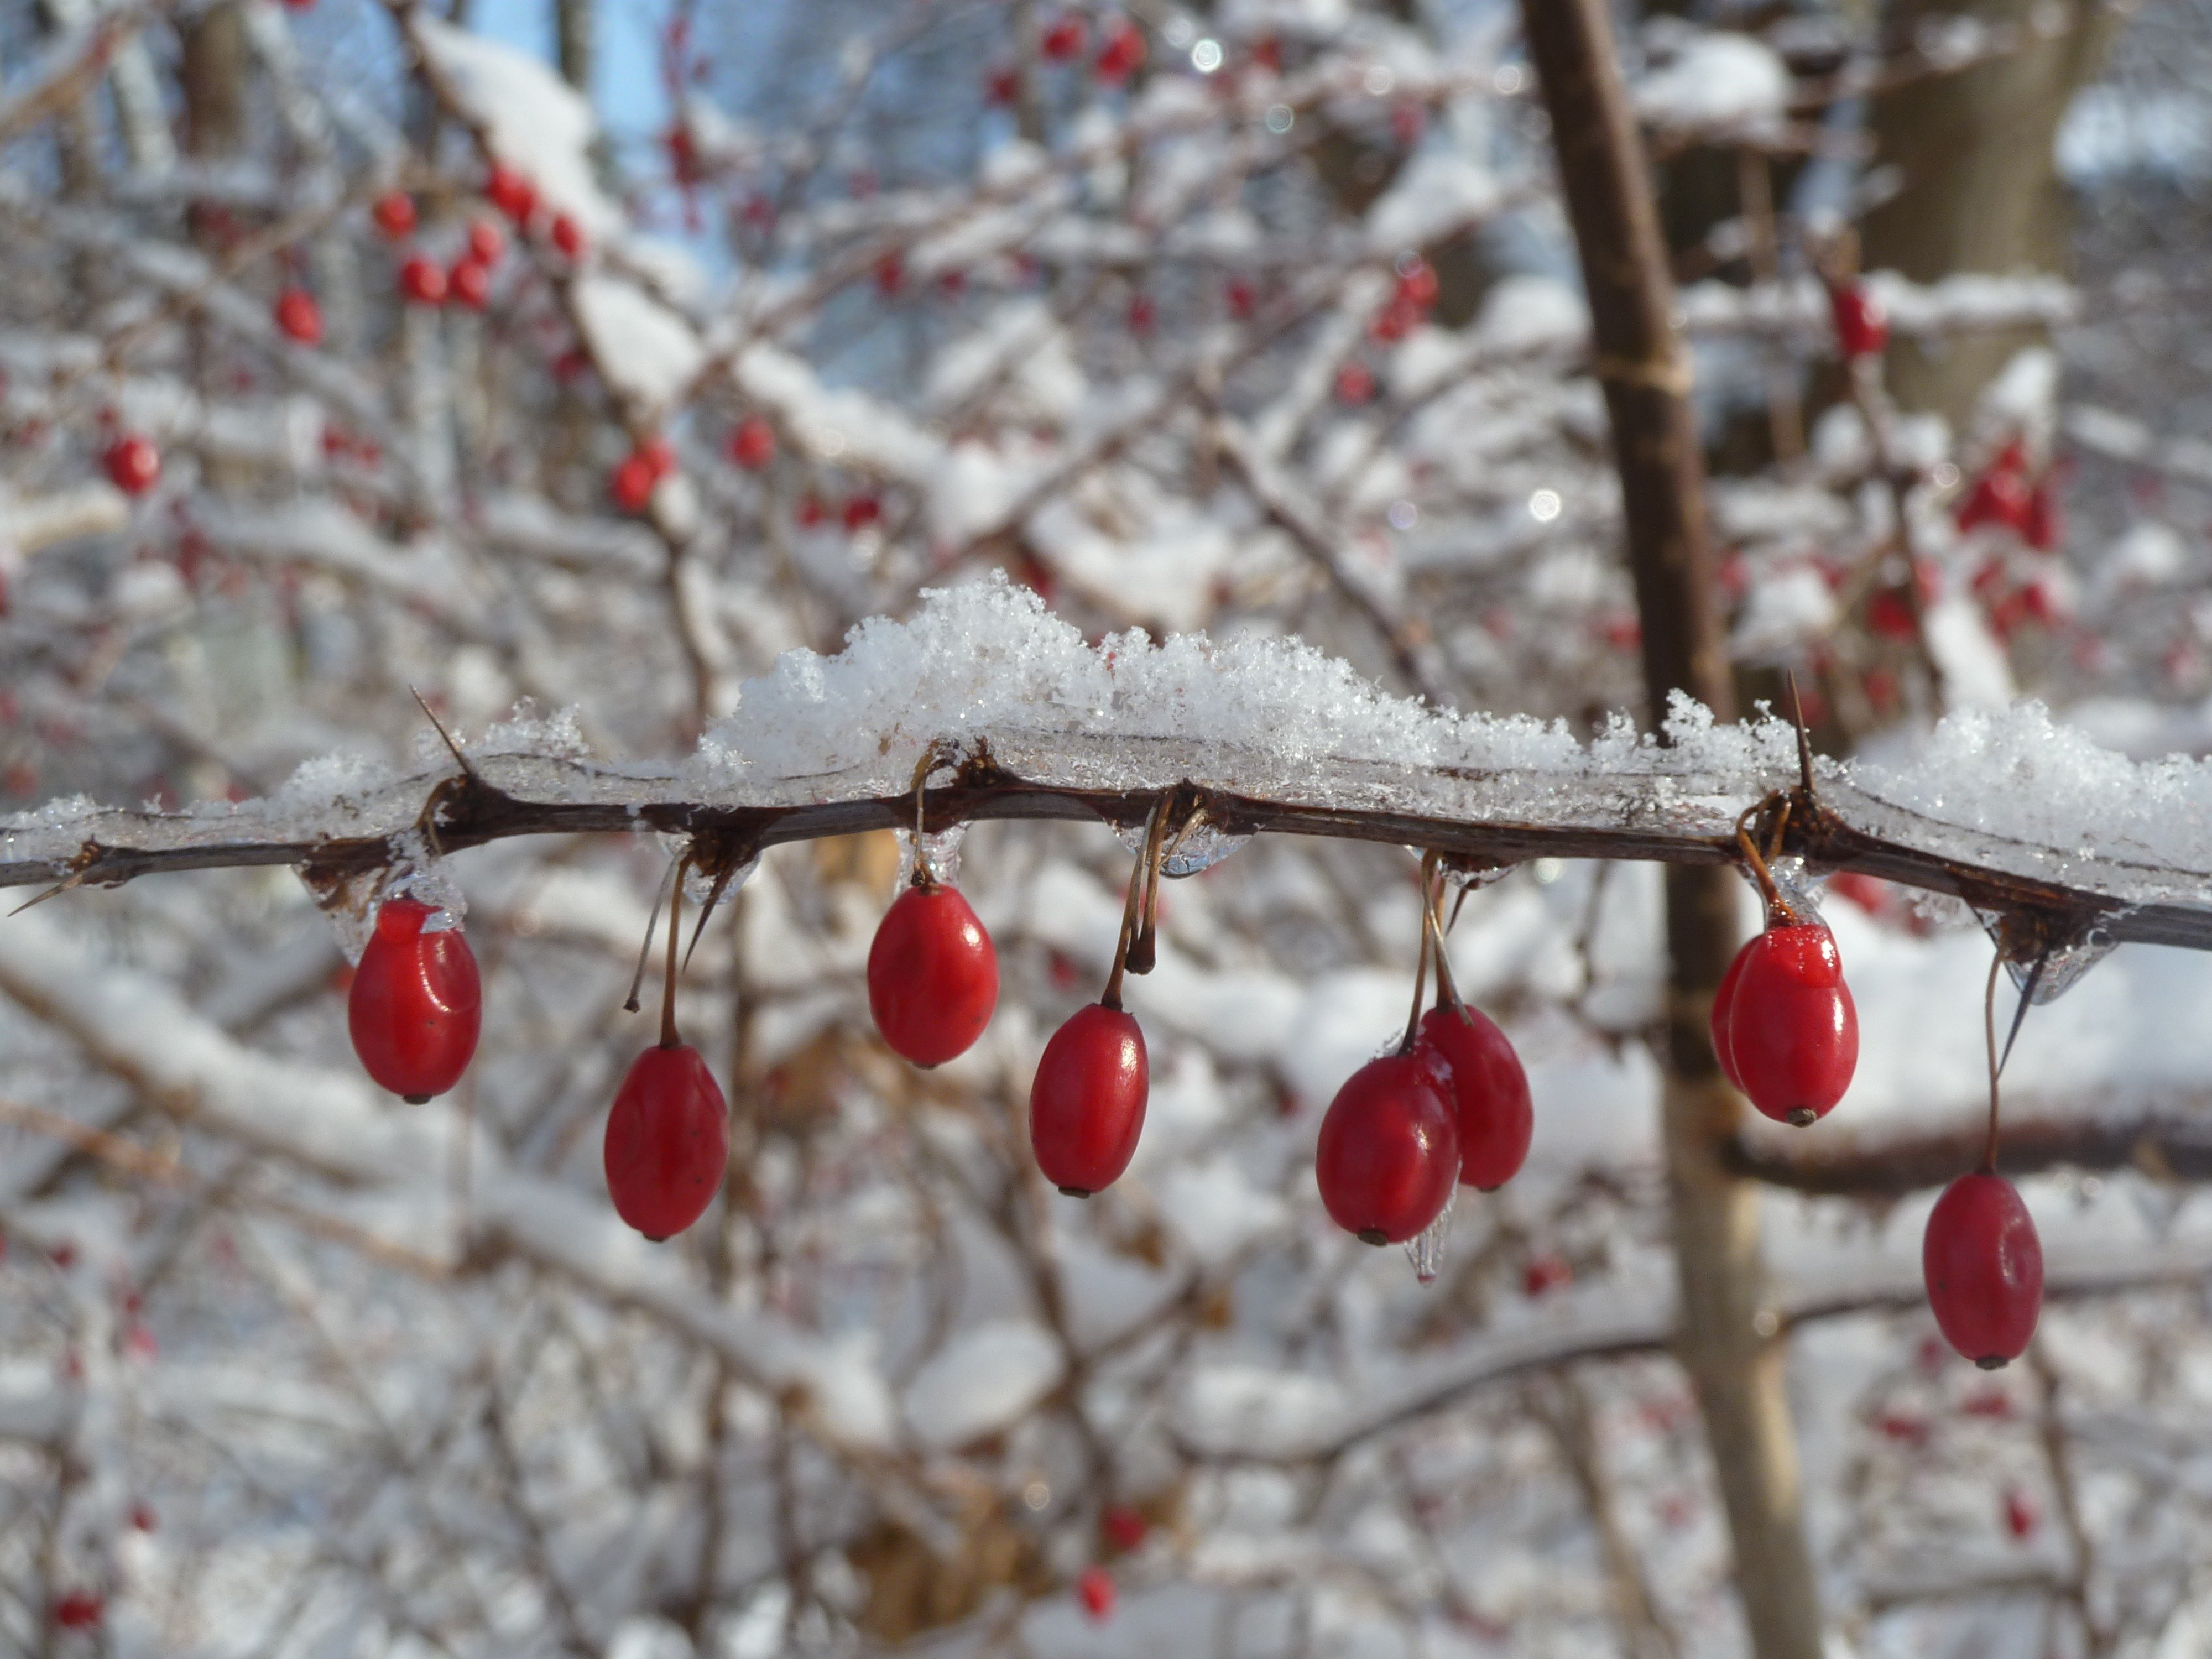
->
left=867, top=883, right=998, bottom=1068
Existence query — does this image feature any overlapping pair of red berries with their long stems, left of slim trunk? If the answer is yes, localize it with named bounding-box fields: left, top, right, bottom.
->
left=1314, top=854, right=1535, bottom=1245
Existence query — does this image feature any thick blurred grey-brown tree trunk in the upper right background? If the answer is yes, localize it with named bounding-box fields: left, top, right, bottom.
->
left=1860, top=0, right=2117, bottom=427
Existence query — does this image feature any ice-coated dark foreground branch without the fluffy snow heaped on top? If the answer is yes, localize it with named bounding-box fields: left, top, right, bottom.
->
left=0, top=730, right=2212, bottom=949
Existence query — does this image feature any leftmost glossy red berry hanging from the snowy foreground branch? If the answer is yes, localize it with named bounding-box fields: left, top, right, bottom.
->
left=345, top=898, right=484, bottom=1106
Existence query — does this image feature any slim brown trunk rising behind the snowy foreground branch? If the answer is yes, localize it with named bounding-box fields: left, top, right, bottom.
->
left=1522, top=0, right=1820, bottom=1659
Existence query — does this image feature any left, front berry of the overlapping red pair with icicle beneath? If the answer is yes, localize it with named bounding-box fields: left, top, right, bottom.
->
left=1314, top=1053, right=1460, bottom=1245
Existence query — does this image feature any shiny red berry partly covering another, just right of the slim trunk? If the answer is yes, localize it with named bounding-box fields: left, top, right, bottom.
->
left=1714, top=922, right=1858, bottom=1128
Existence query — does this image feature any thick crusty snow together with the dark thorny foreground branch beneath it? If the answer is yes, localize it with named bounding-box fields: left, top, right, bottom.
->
left=13, top=577, right=2212, bottom=949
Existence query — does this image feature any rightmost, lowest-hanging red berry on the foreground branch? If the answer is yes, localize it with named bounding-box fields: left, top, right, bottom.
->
left=1920, top=1175, right=2044, bottom=1371
